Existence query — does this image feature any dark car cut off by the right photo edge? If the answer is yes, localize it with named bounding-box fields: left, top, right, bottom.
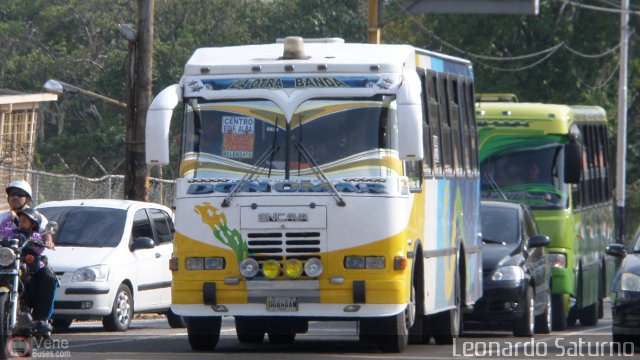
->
left=606, top=228, right=640, bottom=344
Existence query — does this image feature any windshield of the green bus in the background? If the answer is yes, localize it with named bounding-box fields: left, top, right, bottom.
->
left=480, top=137, right=568, bottom=209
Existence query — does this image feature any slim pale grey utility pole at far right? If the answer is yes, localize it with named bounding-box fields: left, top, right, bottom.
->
left=615, top=0, right=629, bottom=244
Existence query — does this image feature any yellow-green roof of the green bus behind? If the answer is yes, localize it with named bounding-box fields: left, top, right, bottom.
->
left=476, top=102, right=607, bottom=123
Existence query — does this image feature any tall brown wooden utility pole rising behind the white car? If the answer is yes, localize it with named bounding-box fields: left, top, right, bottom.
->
left=124, top=0, right=154, bottom=201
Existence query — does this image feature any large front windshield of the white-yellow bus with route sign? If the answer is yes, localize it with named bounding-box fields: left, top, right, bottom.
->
left=181, top=95, right=397, bottom=178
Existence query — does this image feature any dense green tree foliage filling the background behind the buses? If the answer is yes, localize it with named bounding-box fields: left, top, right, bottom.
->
left=0, top=0, right=640, bottom=231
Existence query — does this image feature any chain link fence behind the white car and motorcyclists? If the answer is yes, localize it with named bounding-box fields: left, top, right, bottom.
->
left=0, top=166, right=175, bottom=209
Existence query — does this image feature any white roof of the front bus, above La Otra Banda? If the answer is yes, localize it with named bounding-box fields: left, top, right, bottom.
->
left=184, top=40, right=471, bottom=76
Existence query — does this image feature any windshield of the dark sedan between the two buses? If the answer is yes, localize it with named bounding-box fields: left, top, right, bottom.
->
left=480, top=205, right=520, bottom=244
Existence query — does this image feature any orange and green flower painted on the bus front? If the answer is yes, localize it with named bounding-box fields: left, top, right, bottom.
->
left=194, top=202, right=248, bottom=263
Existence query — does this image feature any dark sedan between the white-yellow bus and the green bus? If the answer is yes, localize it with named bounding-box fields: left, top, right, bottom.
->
left=464, top=200, right=551, bottom=336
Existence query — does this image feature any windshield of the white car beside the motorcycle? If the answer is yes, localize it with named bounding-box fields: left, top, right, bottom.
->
left=38, top=206, right=127, bottom=247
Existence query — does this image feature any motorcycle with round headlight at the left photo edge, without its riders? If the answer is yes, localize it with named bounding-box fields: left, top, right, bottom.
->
left=0, top=221, right=58, bottom=359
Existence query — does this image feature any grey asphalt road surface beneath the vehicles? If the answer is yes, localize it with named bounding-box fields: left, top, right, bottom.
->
left=26, top=304, right=638, bottom=360
